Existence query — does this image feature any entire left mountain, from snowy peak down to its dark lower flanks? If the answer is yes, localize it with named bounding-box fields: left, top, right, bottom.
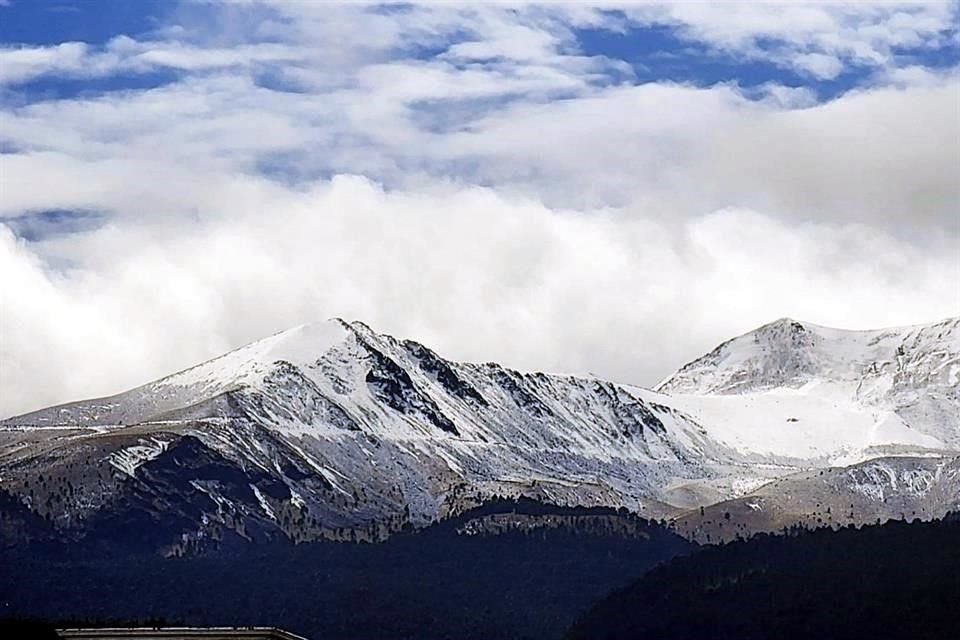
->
left=0, top=320, right=738, bottom=552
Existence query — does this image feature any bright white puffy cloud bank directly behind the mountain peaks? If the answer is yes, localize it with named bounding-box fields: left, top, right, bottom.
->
left=0, top=177, right=960, bottom=420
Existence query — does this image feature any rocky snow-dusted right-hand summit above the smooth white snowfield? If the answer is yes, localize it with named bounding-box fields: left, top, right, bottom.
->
left=656, top=318, right=960, bottom=448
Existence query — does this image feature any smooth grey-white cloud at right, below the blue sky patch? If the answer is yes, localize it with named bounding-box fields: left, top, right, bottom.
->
left=426, top=78, right=960, bottom=232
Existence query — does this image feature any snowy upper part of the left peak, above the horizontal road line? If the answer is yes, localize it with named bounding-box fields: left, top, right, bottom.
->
left=3, top=320, right=715, bottom=460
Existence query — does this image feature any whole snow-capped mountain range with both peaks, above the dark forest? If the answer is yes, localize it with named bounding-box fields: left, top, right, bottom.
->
left=0, top=320, right=960, bottom=550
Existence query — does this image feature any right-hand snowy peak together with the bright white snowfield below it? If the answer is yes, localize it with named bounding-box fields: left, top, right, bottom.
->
left=657, top=319, right=960, bottom=462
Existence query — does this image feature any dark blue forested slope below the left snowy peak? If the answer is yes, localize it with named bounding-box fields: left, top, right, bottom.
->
left=0, top=500, right=696, bottom=640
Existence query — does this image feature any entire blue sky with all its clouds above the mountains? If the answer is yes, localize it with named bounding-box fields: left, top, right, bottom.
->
left=0, top=0, right=960, bottom=415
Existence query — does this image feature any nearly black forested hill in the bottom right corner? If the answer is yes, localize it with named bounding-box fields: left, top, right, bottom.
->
left=569, top=517, right=960, bottom=640
